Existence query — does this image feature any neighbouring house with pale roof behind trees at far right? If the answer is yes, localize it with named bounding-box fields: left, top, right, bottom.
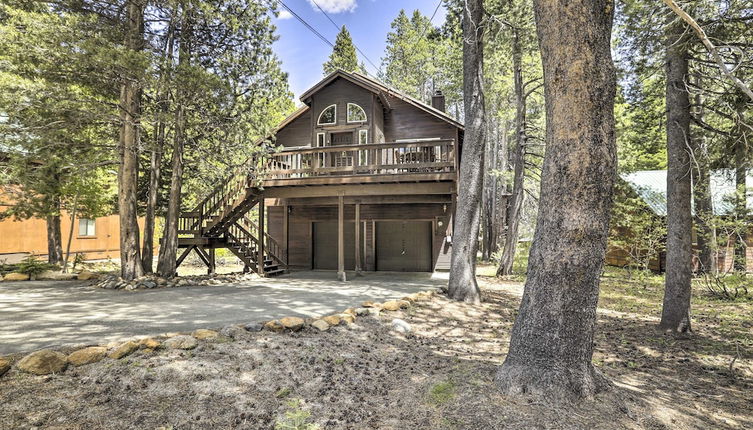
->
left=606, top=169, right=753, bottom=271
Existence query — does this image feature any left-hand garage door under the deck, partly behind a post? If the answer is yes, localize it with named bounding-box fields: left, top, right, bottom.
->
left=313, top=221, right=364, bottom=270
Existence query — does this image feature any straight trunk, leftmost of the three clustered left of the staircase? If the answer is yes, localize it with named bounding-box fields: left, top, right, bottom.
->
left=118, top=0, right=145, bottom=280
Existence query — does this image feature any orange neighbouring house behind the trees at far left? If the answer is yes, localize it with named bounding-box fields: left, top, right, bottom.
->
left=0, top=204, right=144, bottom=263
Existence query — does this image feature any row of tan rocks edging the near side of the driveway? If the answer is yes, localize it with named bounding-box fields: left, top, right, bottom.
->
left=0, top=289, right=438, bottom=377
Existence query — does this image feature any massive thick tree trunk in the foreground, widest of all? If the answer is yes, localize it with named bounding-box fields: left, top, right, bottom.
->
left=497, top=0, right=617, bottom=400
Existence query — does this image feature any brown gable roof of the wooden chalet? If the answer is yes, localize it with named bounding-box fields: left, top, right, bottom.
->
left=300, top=69, right=465, bottom=130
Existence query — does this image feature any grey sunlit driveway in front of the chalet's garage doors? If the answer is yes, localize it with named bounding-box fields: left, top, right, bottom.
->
left=0, top=272, right=447, bottom=354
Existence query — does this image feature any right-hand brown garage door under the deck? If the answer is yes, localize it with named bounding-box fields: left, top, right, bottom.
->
left=376, top=221, right=432, bottom=272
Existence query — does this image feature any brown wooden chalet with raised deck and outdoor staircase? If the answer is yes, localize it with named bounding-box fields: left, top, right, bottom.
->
left=178, top=70, right=463, bottom=280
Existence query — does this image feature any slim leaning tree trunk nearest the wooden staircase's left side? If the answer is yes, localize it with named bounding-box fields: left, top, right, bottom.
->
left=157, top=10, right=191, bottom=278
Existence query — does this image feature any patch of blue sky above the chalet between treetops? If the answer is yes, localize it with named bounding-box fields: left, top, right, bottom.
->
left=273, top=0, right=446, bottom=101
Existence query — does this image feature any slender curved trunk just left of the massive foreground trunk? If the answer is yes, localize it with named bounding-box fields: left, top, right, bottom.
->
left=497, top=28, right=528, bottom=276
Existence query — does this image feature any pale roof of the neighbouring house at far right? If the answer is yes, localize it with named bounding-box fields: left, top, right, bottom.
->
left=620, top=169, right=753, bottom=216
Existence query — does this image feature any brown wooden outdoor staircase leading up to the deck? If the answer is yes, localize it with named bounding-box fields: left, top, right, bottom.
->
left=177, top=163, right=288, bottom=276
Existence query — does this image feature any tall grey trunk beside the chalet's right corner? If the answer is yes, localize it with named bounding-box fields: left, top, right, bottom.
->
left=448, top=0, right=485, bottom=303
